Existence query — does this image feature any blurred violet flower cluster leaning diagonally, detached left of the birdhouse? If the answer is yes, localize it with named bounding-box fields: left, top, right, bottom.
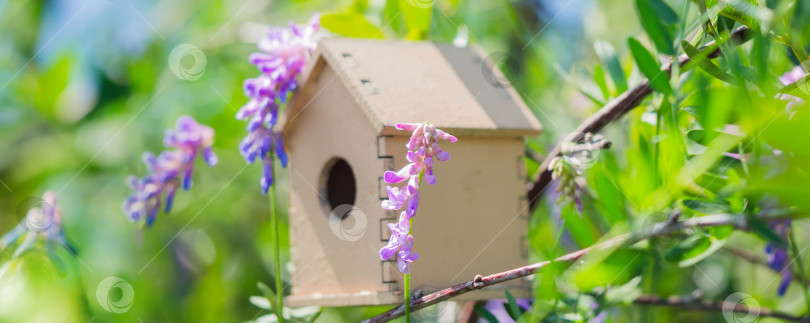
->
left=122, top=116, right=217, bottom=227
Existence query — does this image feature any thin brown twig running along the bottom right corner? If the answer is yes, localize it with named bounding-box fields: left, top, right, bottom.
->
left=633, top=295, right=810, bottom=322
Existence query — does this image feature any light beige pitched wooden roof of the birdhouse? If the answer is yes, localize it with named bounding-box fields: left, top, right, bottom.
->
left=284, top=38, right=541, bottom=136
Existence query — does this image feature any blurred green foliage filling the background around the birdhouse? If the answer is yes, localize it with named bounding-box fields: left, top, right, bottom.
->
left=0, top=0, right=810, bottom=322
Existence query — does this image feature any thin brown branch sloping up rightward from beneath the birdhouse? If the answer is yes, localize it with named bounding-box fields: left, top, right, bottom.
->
left=364, top=213, right=795, bottom=323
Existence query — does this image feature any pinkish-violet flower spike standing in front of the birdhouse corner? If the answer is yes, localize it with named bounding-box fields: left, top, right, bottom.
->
left=380, top=122, right=458, bottom=274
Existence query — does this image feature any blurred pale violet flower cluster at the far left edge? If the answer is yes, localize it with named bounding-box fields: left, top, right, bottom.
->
left=0, top=191, right=76, bottom=257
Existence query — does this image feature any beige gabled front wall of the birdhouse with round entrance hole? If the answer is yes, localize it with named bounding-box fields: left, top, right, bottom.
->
left=287, top=66, right=396, bottom=306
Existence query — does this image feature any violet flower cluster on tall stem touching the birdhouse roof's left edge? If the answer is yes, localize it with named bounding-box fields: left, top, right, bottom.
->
left=236, top=13, right=320, bottom=194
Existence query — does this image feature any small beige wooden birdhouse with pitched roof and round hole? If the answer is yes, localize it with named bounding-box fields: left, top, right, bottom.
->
left=282, top=38, right=541, bottom=306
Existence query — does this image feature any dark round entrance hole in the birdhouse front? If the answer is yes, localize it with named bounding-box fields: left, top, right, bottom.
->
left=320, top=157, right=357, bottom=218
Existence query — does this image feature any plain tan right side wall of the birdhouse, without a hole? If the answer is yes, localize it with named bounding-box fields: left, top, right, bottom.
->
left=379, top=132, right=528, bottom=299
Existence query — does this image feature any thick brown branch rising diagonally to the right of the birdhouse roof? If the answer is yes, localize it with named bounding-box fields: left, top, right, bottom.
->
left=527, top=27, right=752, bottom=214
